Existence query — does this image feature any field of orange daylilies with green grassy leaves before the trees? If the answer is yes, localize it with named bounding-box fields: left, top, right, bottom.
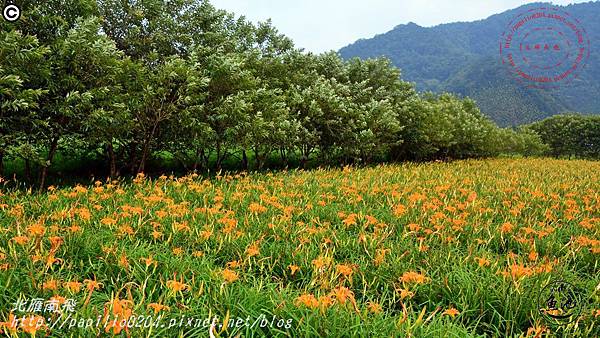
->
left=0, top=159, right=600, bottom=337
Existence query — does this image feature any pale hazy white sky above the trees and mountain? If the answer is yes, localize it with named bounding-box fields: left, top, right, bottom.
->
left=211, top=0, right=589, bottom=52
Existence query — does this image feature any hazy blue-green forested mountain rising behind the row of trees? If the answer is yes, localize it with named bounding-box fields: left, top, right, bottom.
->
left=339, top=1, right=600, bottom=126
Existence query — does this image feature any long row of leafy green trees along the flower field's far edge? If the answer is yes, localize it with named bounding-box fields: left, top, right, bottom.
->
left=0, top=0, right=598, bottom=187
